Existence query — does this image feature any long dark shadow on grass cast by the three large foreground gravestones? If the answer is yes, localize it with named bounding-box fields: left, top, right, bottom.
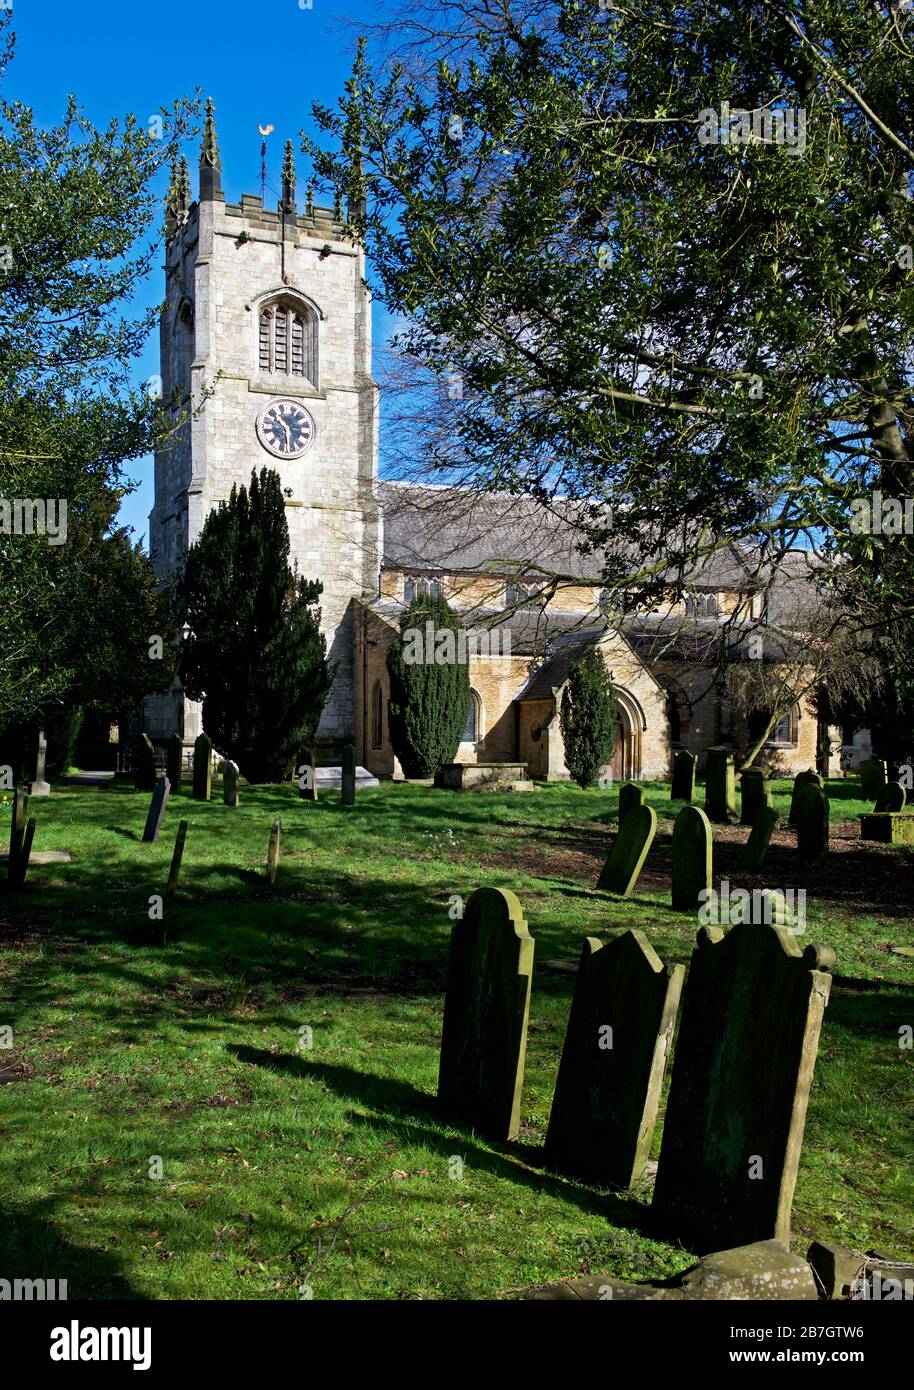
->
left=228, top=1044, right=651, bottom=1236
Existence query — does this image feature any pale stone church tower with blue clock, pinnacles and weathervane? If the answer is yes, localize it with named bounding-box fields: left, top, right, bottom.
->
left=144, top=103, right=381, bottom=741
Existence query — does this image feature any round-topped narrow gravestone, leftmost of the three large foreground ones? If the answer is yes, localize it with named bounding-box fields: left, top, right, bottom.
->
left=438, top=888, right=533, bottom=1143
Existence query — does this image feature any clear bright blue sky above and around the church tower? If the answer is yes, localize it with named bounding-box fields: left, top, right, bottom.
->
left=4, top=0, right=388, bottom=550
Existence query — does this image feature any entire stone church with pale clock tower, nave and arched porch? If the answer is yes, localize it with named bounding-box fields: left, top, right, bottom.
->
left=144, top=103, right=840, bottom=780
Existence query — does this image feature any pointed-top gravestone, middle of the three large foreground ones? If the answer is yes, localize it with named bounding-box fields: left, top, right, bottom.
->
left=545, top=931, right=685, bottom=1187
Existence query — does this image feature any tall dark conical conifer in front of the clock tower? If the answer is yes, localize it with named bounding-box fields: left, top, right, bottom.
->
left=179, top=468, right=333, bottom=783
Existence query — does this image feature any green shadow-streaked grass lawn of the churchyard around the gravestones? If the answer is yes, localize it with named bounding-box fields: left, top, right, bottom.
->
left=0, top=778, right=914, bottom=1298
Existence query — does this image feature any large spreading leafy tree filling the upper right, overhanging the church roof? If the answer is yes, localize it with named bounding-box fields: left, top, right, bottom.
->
left=306, top=0, right=914, bottom=631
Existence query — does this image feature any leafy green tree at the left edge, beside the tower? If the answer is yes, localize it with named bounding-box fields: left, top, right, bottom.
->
left=0, top=15, right=192, bottom=728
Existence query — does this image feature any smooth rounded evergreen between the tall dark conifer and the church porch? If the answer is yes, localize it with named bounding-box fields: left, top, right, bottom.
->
left=388, top=595, right=471, bottom=777
